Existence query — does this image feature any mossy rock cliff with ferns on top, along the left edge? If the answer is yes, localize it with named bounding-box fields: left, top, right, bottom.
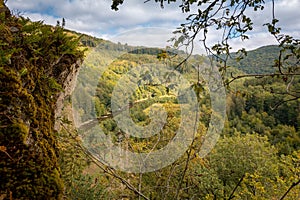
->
left=0, top=1, right=83, bottom=199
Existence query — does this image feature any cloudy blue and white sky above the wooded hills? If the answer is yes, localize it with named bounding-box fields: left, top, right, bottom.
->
left=7, top=0, right=300, bottom=53
